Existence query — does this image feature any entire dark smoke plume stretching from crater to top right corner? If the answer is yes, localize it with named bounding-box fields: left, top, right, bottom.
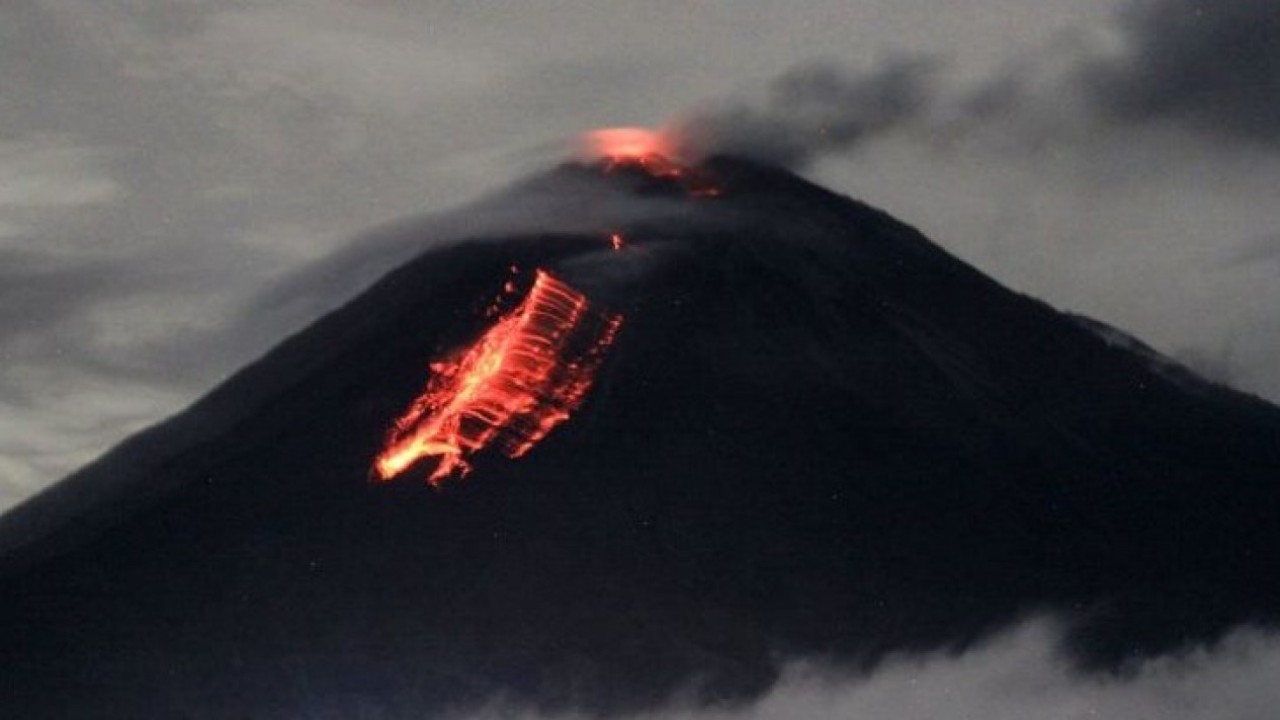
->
left=675, top=0, right=1280, bottom=168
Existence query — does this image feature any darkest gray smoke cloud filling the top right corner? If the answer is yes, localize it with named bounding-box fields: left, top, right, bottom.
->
left=1083, top=0, right=1280, bottom=145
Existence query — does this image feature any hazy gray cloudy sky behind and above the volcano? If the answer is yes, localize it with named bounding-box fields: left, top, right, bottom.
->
left=0, top=0, right=1280, bottom=507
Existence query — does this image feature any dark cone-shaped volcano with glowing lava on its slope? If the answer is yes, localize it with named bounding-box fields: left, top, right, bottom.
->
left=0, top=158, right=1280, bottom=717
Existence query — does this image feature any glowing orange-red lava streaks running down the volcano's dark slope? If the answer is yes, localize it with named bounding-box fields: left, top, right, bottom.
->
left=374, top=270, right=622, bottom=487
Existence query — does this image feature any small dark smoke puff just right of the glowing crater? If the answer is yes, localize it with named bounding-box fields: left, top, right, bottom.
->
left=675, top=56, right=937, bottom=168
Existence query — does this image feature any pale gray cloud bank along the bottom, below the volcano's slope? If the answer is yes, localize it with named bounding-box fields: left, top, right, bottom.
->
left=454, top=621, right=1280, bottom=720
